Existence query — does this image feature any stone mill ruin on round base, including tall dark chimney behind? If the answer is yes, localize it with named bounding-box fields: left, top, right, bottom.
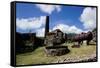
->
left=44, top=16, right=69, bottom=56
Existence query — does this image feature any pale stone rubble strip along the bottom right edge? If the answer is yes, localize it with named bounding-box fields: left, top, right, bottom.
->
left=52, top=54, right=97, bottom=63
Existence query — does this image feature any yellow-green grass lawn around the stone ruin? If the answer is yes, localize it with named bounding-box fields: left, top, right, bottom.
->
left=16, top=42, right=96, bottom=65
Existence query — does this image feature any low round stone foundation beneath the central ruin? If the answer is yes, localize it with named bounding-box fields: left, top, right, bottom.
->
left=44, top=46, right=69, bottom=56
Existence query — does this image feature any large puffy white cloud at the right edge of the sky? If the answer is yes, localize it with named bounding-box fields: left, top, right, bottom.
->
left=80, top=7, right=96, bottom=30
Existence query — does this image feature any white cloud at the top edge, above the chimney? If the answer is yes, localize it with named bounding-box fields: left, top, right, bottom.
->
left=36, top=4, right=61, bottom=14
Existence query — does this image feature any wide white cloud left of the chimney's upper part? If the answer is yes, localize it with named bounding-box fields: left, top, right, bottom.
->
left=16, top=16, right=46, bottom=30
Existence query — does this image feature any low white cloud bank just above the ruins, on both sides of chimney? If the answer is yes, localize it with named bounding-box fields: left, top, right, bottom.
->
left=36, top=23, right=87, bottom=37
